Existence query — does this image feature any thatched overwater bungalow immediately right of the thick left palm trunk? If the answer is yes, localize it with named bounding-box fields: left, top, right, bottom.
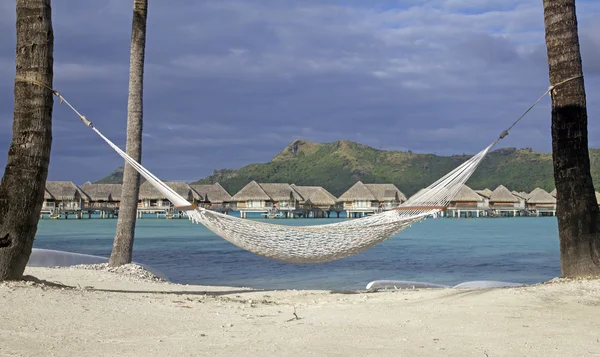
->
left=43, top=181, right=90, bottom=218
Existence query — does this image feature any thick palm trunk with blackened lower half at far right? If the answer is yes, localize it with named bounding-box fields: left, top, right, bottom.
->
left=544, top=0, right=600, bottom=277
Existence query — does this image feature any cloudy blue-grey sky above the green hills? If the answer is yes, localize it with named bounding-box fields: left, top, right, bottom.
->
left=0, top=0, right=600, bottom=183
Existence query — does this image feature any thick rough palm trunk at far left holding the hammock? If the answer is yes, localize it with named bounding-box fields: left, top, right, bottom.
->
left=0, top=0, right=54, bottom=281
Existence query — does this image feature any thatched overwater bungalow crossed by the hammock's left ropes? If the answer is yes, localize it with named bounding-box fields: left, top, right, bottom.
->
left=137, top=181, right=201, bottom=218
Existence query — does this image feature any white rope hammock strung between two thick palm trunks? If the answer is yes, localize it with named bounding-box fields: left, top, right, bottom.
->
left=17, top=77, right=579, bottom=263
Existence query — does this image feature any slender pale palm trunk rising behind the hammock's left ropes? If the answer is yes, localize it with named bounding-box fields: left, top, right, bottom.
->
left=109, top=0, right=148, bottom=266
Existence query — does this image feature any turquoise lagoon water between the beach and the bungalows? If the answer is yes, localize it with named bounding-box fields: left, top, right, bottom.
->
left=34, top=217, right=560, bottom=289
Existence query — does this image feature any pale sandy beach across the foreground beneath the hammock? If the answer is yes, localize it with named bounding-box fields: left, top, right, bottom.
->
left=0, top=268, right=600, bottom=357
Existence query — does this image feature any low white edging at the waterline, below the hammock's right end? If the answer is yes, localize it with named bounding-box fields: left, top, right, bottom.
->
left=367, top=280, right=526, bottom=291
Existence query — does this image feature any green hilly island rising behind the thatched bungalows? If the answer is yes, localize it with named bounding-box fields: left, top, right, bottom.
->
left=96, top=139, right=600, bottom=196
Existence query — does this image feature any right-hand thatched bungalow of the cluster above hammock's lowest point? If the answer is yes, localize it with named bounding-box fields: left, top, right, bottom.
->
left=291, top=184, right=343, bottom=218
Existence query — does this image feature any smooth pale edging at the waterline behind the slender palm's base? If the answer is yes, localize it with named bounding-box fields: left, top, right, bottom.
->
left=27, top=248, right=169, bottom=280
